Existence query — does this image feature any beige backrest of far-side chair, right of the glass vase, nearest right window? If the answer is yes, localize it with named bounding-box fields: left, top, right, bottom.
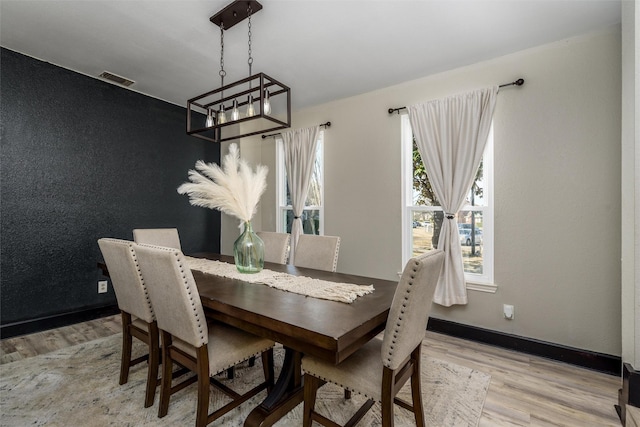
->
left=293, top=234, right=340, bottom=271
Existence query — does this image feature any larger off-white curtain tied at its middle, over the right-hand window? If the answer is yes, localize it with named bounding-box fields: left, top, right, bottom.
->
left=407, top=86, right=498, bottom=307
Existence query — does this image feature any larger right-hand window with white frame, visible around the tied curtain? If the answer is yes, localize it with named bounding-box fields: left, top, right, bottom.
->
left=402, top=115, right=495, bottom=292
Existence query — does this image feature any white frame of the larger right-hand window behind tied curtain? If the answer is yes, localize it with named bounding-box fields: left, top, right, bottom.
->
left=401, top=114, right=497, bottom=293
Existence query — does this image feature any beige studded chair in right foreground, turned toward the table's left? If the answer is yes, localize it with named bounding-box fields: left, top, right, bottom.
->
left=302, top=249, right=444, bottom=427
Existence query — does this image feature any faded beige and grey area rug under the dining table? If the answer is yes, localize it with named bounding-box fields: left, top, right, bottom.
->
left=0, top=334, right=491, bottom=427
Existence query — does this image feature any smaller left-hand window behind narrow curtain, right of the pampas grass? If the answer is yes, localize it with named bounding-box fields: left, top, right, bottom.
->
left=276, top=131, right=324, bottom=234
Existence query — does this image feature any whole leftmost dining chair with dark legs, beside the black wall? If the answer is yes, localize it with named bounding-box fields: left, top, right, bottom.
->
left=98, top=239, right=160, bottom=408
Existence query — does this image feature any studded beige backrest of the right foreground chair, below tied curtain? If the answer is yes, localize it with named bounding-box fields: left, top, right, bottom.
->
left=381, top=249, right=444, bottom=370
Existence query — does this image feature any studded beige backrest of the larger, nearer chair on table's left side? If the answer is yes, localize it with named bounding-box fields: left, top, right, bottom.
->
left=135, top=244, right=209, bottom=348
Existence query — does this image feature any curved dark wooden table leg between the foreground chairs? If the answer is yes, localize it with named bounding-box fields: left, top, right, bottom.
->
left=244, top=347, right=304, bottom=427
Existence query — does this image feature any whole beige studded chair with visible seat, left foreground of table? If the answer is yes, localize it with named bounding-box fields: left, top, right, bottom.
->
left=135, top=244, right=275, bottom=427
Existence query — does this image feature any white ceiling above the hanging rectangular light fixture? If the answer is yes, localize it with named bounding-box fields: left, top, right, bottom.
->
left=0, top=0, right=630, bottom=110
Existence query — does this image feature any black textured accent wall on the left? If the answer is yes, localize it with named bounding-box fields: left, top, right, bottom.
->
left=0, top=49, right=220, bottom=326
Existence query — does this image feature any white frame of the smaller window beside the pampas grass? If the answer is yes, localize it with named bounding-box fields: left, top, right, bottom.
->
left=276, top=130, right=326, bottom=236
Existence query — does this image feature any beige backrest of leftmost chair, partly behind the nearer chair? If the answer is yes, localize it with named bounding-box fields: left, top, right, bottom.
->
left=98, top=238, right=156, bottom=323
